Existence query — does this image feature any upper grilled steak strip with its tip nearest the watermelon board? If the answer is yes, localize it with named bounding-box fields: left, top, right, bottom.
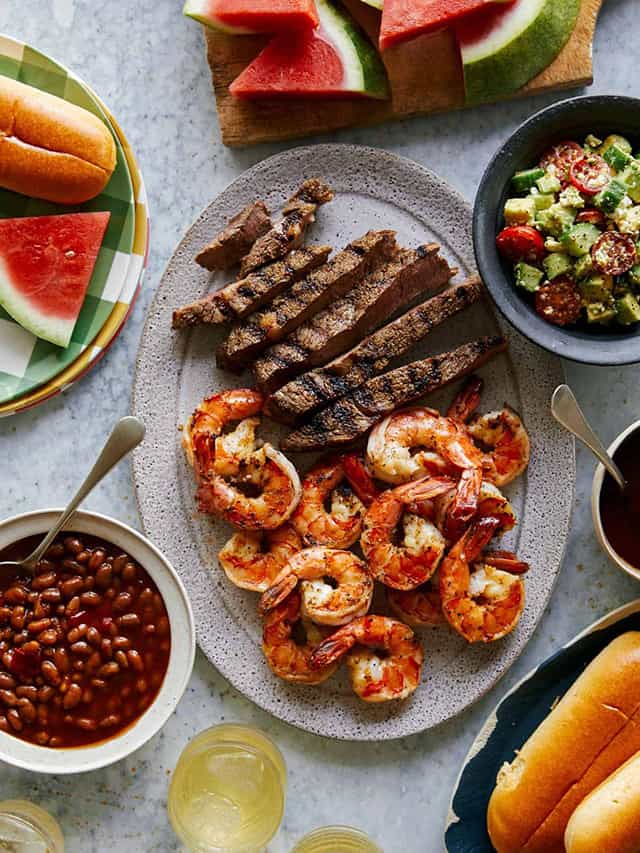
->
left=240, top=178, right=333, bottom=278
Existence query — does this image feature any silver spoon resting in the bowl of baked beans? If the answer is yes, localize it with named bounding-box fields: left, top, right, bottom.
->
left=0, top=417, right=144, bottom=576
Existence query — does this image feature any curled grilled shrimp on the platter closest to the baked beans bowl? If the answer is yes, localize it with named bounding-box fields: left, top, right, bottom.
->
left=218, top=524, right=302, bottom=592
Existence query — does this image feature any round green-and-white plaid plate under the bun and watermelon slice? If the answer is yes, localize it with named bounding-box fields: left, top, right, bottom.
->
left=0, top=35, right=136, bottom=405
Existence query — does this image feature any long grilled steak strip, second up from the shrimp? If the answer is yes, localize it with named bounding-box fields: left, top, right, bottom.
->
left=265, top=276, right=483, bottom=424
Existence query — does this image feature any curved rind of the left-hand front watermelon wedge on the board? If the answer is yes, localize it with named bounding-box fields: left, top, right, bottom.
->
left=316, top=0, right=389, bottom=99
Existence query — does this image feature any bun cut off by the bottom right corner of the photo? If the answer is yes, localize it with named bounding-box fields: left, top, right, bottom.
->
left=564, top=753, right=640, bottom=853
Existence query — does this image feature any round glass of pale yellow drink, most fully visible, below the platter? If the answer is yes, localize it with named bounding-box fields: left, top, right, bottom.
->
left=168, top=724, right=287, bottom=853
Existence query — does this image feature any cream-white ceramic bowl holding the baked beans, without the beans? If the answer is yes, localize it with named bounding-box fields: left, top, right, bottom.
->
left=0, top=509, right=196, bottom=773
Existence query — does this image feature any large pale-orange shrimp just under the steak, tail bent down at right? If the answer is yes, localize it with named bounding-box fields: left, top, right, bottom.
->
left=367, top=408, right=483, bottom=522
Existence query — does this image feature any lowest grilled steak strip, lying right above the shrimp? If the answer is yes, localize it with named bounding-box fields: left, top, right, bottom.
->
left=281, top=336, right=507, bottom=452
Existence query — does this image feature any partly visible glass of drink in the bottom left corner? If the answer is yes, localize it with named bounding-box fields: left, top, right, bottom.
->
left=0, top=800, right=64, bottom=853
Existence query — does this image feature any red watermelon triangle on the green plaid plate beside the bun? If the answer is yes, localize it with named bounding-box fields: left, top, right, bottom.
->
left=0, top=212, right=111, bottom=347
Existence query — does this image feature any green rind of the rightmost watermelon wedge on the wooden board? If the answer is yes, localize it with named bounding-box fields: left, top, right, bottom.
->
left=460, top=0, right=580, bottom=104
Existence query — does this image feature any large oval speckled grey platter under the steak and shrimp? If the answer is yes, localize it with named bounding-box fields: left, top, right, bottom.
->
left=133, top=145, right=575, bottom=740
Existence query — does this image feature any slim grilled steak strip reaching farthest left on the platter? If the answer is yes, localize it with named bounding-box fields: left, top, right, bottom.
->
left=172, top=246, right=331, bottom=329
